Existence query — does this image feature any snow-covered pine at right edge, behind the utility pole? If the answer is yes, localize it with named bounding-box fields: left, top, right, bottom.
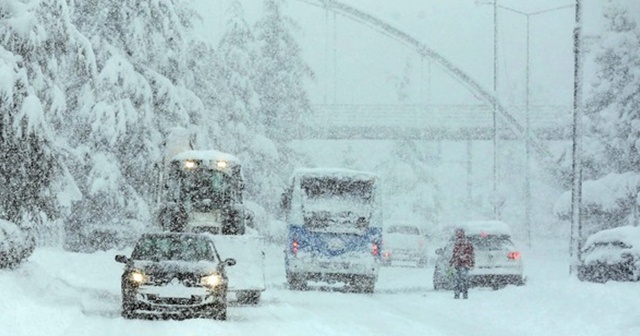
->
left=556, top=1, right=640, bottom=238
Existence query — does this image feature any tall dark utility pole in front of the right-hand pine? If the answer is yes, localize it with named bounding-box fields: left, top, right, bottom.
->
left=569, top=0, right=582, bottom=274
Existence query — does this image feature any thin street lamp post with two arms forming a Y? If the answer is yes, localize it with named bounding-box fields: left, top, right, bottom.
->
left=497, top=4, right=574, bottom=247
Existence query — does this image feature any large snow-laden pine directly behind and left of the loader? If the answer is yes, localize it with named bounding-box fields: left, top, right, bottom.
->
left=64, top=0, right=211, bottom=247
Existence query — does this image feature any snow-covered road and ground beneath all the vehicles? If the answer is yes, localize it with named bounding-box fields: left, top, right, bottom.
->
left=0, top=240, right=640, bottom=336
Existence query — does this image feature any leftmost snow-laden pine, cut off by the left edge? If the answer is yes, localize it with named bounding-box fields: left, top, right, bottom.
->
left=0, top=0, right=90, bottom=238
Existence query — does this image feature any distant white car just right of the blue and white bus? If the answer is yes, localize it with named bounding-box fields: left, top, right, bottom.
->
left=382, top=221, right=428, bottom=267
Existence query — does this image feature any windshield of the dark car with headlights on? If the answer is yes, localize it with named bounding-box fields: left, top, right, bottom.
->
left=131, top=236, right=214, bottom=261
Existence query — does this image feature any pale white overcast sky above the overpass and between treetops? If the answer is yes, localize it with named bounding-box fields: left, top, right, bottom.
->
left=194, top=0, right=640, bottom=106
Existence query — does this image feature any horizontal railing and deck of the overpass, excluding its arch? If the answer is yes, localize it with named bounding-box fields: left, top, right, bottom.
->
left=305, top=104, right=571, bottom=139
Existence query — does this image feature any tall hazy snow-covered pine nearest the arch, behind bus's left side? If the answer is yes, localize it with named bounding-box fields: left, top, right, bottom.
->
left=247, top=0, right=313, bottom=212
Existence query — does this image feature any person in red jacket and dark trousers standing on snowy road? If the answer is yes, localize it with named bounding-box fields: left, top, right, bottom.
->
left=449, top=229, right=475, bottom=299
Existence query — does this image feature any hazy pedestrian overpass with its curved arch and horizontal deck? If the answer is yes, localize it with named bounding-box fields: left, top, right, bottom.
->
left=287, top=0, right=572, bottom=170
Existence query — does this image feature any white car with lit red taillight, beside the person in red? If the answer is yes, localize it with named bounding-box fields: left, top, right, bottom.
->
left=433, top=220, right=525, bottom=290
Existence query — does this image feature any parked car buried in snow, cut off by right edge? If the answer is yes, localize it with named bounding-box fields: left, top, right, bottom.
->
left=578, top=226, right=640, bottom=282
